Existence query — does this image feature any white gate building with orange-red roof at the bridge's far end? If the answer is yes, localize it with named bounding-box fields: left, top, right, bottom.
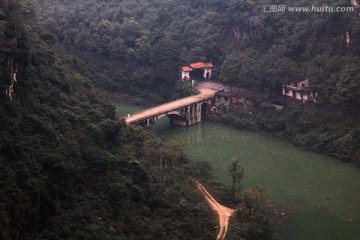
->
left=181, top=62, right=214, bottom=80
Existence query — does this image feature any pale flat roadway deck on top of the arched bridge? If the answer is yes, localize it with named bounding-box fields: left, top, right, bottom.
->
left=125, top=86, right=217, bottom=124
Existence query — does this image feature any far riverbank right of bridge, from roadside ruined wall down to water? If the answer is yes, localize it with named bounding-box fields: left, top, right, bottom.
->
left=197, top=79, right=360, bottom=166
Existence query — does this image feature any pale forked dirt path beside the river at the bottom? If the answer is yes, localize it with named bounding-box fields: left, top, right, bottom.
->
left=196, top=181, right=235, bottom=240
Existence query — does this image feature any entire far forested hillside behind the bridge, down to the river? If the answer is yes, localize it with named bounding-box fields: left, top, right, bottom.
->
left=28, top=0, right=360, bottom=163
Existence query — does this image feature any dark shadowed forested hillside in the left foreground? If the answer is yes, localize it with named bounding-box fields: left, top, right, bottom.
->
left=0, top=0, right=222, bottom=240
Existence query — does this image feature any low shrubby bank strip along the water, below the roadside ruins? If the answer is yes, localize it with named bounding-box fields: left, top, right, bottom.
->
left=207, top=104, right=360, bottom=167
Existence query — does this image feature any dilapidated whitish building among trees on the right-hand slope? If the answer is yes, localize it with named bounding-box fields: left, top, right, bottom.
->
left=283, top=79, right=317, bottom=102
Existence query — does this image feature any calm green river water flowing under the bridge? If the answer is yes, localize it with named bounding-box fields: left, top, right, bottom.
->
left=115, top=102, right=360, bottom=240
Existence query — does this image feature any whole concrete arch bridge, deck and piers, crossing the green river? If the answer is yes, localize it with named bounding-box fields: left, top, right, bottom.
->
left=125, top=86, right=217, bottom=126
